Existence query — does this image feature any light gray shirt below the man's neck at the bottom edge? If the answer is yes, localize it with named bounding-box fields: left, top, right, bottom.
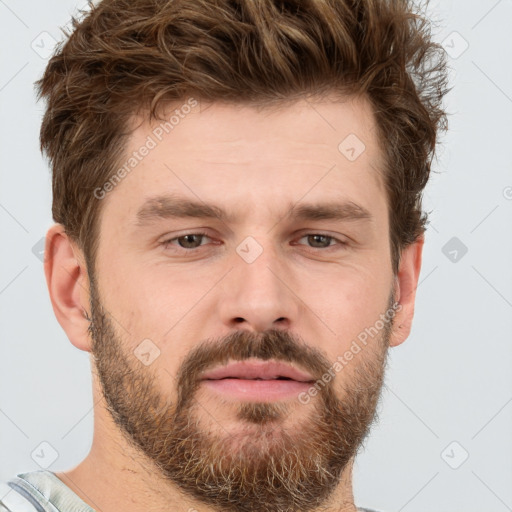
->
left=0, top=470, right=384, bottom=512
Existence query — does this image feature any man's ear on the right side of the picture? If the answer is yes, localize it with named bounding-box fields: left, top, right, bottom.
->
left=389, top=235, right=425, bottom=347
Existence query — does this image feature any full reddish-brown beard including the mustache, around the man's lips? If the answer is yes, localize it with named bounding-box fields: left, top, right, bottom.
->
left=89, top=279, right=394, bottom=512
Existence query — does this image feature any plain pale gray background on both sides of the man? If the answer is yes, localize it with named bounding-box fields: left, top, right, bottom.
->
left=0, top=0, right=512, bottom=512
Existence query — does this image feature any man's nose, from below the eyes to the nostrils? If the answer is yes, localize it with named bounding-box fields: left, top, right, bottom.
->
left=219, top=240, right=301, bottom=332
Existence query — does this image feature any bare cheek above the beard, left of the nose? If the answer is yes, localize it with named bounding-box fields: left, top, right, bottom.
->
left=100, top=263, right=210, bottom=370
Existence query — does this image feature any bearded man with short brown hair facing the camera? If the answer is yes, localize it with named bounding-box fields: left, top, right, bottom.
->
left=1, top=0, right=447, bottom=512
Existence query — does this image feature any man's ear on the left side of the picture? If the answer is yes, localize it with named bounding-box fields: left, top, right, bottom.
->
left=44, top=224, right=91, bottom=352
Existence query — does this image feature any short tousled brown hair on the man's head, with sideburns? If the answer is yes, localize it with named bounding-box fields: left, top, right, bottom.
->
left=36, top=0, right=449, bottom=273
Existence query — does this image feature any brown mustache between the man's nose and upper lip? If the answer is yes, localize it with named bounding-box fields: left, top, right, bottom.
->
left=177, top=329, right=330, bottom=410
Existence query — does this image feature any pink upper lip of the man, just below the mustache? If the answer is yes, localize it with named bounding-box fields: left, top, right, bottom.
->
left=201, top=361, right=314, bottom=382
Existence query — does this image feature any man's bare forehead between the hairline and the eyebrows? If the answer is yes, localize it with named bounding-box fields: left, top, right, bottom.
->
left=99, top=94, right=385, bottom=226
